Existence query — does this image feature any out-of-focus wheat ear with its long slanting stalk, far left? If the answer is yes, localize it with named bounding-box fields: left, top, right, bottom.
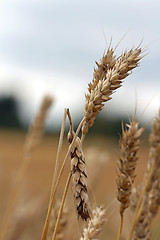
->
left=0, top=96, right=53, bottom=240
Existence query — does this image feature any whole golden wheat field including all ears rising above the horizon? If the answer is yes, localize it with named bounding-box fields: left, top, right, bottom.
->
left=0, top=43, right=160, bottom=240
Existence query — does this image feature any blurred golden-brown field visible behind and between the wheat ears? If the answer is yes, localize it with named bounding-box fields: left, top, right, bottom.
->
left=0, top=129, right=160, bottom=240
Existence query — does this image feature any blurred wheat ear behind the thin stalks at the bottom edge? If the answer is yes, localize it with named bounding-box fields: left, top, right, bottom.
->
left=47, top=201, right=68, bottom=240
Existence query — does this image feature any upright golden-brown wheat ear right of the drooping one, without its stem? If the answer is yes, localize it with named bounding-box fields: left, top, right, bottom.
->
left=117, top=120, right=144, bottom=215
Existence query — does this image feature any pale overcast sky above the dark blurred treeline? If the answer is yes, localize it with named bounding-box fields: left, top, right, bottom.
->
left=0, top=0, right=160, bottom=129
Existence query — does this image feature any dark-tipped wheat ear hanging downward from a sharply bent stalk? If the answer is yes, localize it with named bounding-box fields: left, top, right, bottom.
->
left=68, top=123, right=91, bottom=220
